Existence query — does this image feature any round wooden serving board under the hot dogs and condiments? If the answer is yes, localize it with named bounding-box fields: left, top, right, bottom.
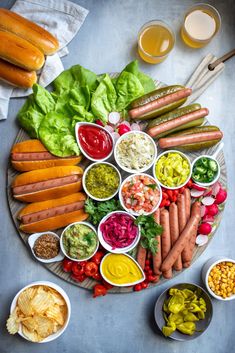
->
left=7, top=81, right=227, bottom=293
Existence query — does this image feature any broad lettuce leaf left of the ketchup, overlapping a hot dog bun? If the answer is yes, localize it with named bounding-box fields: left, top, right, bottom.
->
left=39, top=112, right=80, bottom=157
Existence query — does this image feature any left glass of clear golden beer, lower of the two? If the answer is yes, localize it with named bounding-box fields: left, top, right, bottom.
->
left=138, top=20, right=175, bottom=64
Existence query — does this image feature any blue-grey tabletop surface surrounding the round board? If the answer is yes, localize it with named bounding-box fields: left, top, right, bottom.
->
left=0, top=0, right=235, bottom=353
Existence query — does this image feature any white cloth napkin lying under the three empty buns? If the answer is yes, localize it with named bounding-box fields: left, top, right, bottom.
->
left=0, top=0, right=88, bottom=120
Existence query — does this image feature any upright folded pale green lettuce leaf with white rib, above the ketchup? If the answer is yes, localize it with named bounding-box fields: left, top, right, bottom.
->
left=91, top=74, right=117, bottom=123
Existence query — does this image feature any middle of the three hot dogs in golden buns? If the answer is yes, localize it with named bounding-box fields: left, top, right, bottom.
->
left=12, top=166, right=83, bottom=202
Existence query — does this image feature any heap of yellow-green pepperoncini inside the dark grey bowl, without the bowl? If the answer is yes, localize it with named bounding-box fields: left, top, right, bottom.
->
left=162, top=288, right=206, bottom=337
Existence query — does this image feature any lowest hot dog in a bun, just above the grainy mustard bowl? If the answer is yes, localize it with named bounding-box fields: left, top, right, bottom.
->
left=18, top=192, right=88, bottom=233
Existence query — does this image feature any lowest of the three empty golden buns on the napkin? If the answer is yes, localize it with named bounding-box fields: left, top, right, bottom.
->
left=0, top=59, right=37, bottom=88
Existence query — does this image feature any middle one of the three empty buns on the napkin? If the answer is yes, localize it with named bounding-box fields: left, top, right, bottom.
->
left=0, top=31, right=45, bottom=71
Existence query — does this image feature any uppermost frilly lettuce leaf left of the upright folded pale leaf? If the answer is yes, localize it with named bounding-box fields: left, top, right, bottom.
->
left=53, top=65, right=98, bottom=94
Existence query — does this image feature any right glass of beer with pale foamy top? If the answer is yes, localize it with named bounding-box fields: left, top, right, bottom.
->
left=181, top=4, right=221, bottom=48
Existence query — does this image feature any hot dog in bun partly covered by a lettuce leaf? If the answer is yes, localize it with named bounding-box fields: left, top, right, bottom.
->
left=11, top=139, right=82, bottom=172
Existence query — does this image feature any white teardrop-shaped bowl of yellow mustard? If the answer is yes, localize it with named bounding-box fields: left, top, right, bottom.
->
left=101, top=254, right=145, bottom=286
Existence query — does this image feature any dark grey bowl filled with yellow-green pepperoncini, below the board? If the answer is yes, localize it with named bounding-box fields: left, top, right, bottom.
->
left=154, top=283, right=213, bottom=341
